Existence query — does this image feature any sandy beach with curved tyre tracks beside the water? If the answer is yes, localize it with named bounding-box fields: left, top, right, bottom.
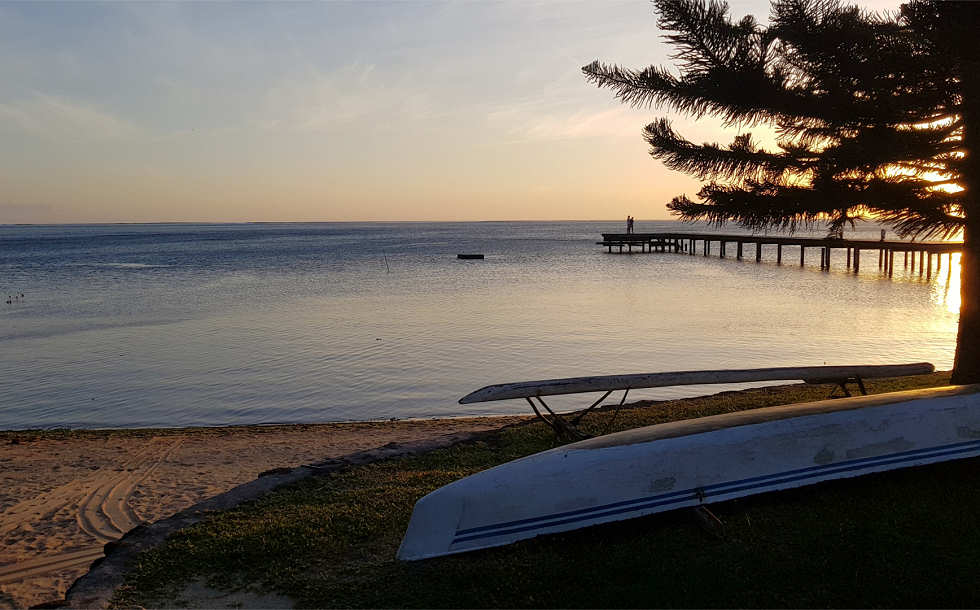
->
left=0, top=417, right=525, bottom=608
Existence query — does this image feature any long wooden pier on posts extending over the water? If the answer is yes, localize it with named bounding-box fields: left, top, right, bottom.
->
left=596, top=233, right=963, bottom=277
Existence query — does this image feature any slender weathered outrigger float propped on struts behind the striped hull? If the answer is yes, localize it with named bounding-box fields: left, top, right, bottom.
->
left=459, top=362, right=935, bottom=405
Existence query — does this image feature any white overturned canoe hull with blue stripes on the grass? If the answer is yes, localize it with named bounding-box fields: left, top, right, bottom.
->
left=398, top=385, right=980, bottom=560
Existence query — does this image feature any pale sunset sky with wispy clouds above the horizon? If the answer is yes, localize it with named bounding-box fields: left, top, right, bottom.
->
left=0, top=0, right=898, bottom=224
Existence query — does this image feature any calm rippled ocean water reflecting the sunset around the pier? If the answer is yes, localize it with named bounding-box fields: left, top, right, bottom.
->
left=0, top=220, right=959, bottom=429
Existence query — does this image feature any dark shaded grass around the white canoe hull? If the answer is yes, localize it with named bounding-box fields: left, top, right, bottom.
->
left=113, top=373, right=980, bottom=607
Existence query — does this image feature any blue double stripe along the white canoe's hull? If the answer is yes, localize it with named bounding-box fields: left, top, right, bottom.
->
left=452, top=440, right=980, bottom=544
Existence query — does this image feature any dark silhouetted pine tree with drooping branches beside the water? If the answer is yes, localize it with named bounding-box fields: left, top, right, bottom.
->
left=583, top=0, right=980, bottom=383
